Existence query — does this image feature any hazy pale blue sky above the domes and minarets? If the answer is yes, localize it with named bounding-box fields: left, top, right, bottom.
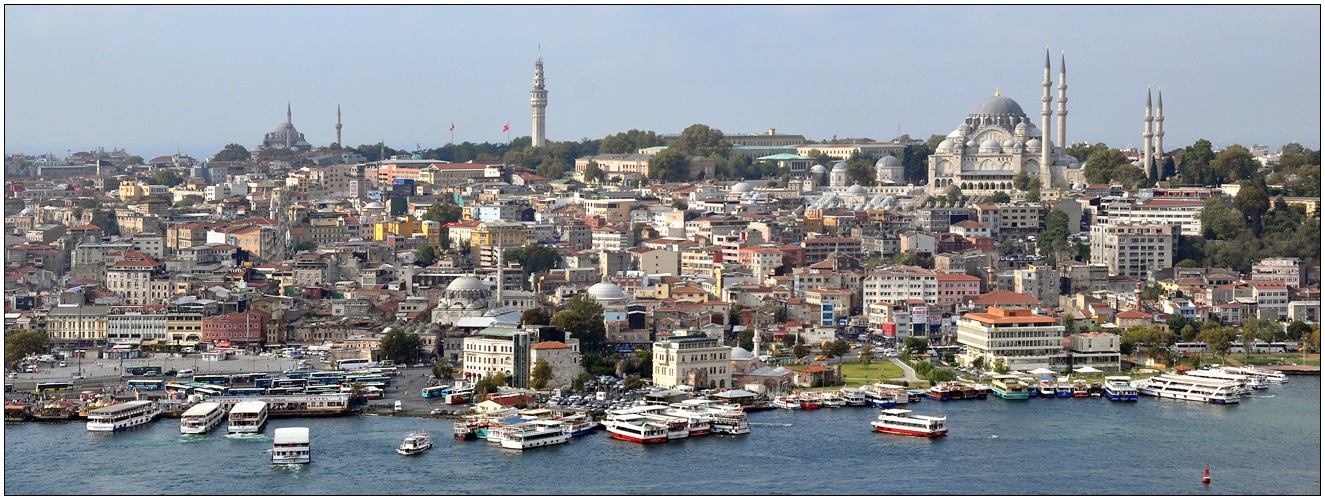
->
left=4, top=5, right=1321, bottom=158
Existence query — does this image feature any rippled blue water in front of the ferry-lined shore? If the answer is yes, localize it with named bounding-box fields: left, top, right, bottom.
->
left=4, top=377, right=1321, bottom=495
